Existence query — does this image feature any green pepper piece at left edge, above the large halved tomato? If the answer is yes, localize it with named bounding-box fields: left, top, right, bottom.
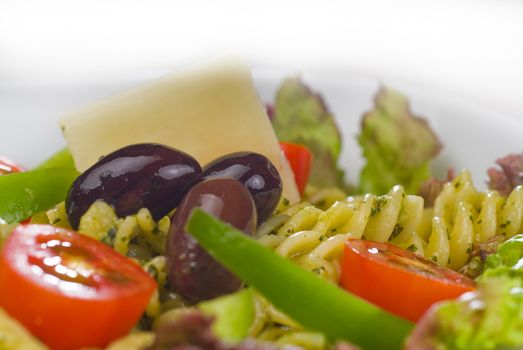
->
left=0, top=169, right=79, bottom=223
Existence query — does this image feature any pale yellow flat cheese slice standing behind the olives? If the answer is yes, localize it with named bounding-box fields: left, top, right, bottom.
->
left=59, top=60, right=300, bottom=203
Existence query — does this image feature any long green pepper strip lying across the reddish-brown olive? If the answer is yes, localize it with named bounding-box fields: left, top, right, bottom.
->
left=186, top=208, right=413, bottom=350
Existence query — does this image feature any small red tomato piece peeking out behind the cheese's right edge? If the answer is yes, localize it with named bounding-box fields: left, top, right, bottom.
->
left=280, top=142, right=312, bottom=195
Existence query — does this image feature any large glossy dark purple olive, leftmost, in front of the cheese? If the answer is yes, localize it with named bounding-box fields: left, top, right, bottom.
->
left=65, top=143, right=202, bottom=228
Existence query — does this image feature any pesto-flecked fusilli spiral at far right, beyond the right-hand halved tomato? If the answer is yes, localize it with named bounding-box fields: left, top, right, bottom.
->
left=426, top=171, right=523, bottom=269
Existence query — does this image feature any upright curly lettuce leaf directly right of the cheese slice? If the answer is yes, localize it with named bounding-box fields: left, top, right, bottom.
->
left=271, top=78, right=345, bottom=188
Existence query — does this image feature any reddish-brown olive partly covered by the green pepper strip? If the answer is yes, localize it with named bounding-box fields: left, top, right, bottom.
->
left=166, top=178, right=256, bottom=302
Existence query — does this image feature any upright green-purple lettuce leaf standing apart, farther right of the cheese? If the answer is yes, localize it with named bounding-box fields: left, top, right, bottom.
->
left=358, top=87, right=441, bottom=194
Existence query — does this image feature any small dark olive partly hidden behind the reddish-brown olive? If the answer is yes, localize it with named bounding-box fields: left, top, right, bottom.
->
left=203, top=152, right=282, bottom=223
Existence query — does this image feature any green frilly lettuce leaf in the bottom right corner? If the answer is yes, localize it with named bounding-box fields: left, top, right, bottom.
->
left=407, top=234, right=523, bottom=350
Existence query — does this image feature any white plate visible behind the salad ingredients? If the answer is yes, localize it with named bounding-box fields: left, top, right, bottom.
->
left=0, top=69, right=523, bottom=188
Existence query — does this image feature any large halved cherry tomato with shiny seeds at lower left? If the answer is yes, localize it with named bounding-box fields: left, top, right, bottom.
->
left=0, top=225, right=156, bottom=350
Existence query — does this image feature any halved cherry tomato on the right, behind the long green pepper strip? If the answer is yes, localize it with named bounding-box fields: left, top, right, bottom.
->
left=340, top=239, right=475, bottom=322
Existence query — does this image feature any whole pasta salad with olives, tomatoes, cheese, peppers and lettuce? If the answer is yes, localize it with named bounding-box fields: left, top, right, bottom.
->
left=0, top=60, right=523, bottom=350
